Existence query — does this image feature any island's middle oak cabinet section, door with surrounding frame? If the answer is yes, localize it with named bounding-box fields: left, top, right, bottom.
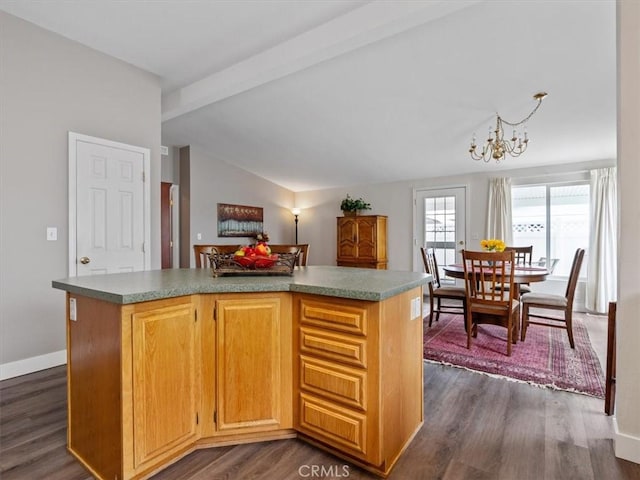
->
left=199, top=292, right=295, bottom=445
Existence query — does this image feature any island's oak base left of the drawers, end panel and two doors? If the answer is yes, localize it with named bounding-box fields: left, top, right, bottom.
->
left=67, top=292, right=296, bottom=479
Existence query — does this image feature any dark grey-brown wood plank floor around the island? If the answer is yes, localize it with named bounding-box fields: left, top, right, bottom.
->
left=0, top=364, right=640, bottom=480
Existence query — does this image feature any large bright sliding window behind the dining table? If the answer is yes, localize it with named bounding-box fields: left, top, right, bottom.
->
left=511, top=182, right=589, bottom=278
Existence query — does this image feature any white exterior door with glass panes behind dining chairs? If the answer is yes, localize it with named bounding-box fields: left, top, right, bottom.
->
left=415, top=187, right=466, bottom=283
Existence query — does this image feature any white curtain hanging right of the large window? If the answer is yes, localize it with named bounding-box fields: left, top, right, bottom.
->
left=585, top=167, right=618, bottom=313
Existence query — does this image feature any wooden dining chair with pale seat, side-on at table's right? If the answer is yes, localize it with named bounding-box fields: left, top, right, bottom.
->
left=520, top=248, right=584, bottom=348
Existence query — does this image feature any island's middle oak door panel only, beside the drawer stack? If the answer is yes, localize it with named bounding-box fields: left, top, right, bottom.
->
left=216, top=297, right=283, bottom=434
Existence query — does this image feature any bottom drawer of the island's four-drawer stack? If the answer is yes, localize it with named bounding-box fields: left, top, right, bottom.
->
left=299, top=393, right=367, bottom=457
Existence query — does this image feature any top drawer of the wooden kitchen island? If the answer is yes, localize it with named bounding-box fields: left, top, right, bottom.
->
left=300, top=298, right=367, bottom=335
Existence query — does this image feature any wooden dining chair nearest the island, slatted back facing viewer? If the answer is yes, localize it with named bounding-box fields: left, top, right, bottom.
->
left=462, top=250, right=520, bottom=357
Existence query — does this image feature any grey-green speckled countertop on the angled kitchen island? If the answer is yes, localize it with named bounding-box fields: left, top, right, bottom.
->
left=52, top=266, right=431, bottom=304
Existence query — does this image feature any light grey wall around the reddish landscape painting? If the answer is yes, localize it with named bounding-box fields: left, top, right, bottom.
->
left=185, top=145, right=295, bottom=267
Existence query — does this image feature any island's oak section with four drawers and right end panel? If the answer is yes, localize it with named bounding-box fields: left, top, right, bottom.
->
left=294, top=288, right=423, bottom=476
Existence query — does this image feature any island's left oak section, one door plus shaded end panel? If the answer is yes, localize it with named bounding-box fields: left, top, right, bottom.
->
left=67, top=294, right=200, bottom=479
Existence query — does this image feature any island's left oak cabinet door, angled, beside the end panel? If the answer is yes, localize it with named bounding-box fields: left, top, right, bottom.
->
left=132, top=303, right=199, bottom=469
